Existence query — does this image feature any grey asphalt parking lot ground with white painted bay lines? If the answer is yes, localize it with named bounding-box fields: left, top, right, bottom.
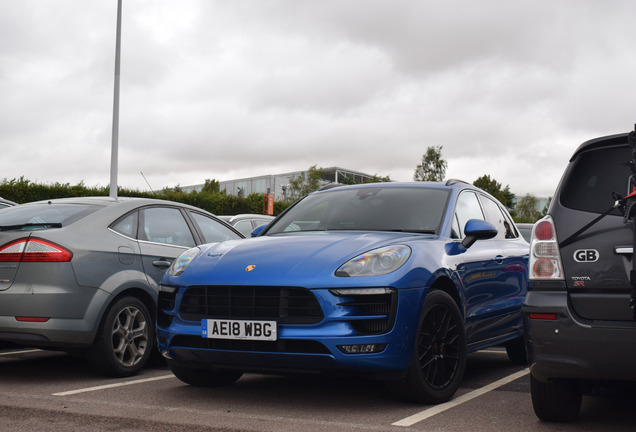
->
left=0, top=349, right=636, bottom=432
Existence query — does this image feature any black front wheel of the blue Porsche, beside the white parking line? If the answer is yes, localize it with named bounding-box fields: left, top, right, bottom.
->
left=387, top=291, right=466, bottom=404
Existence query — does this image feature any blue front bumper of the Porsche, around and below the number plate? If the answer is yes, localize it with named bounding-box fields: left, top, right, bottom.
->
left=157, top=289, right=425, bottom=379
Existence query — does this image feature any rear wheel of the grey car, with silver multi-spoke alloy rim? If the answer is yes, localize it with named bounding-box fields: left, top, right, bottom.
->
left=86, top=296, right=155, bottom=377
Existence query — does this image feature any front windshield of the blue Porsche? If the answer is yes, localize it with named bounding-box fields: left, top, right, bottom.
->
left=267, top=186, right=449, bottom=234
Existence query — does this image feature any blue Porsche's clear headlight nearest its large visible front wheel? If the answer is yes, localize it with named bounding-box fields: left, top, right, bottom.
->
left=336, top=245, right=411, bottom=277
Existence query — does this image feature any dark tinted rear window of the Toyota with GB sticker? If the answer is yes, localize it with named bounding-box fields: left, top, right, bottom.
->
left=560, top=147, right=632, bottom=213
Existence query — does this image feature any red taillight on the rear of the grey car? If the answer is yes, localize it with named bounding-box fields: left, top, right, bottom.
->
left=0, top=238, right=73, bottom=262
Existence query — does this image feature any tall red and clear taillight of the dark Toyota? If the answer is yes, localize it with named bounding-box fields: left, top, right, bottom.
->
left=529, top=216, right=563, bottom=280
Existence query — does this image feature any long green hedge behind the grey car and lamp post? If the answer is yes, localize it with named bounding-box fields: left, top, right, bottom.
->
left=0, top=177, right=291, bottom=215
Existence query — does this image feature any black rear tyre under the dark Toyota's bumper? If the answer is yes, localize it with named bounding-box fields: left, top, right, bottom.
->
left=530, top=375, right=582, bottom=422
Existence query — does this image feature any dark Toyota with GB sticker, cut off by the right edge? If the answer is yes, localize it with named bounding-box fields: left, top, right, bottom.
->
left=523, top=128, right=636, bottom=421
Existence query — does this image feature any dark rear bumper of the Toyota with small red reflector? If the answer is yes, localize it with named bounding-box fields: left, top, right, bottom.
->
left=522, top=290, right=636, bottom=382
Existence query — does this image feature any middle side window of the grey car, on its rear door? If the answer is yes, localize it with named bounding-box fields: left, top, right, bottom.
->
left=140, top=207, right=196, bottom=247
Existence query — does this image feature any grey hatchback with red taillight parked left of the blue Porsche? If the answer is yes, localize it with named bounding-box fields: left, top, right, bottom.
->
left=0, top=197, right=243, bottom=376
